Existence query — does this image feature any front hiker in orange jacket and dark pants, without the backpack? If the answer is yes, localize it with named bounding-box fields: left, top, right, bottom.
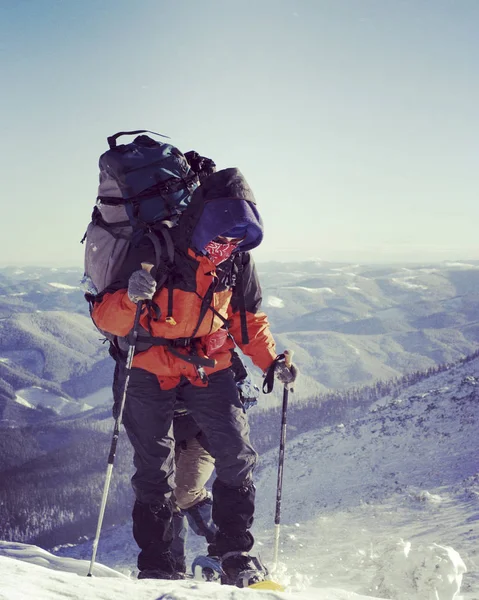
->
left=92, top=169, right=296, bottom=585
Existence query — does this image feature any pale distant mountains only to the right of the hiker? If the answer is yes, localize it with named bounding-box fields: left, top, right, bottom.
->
left=259, top=261, right=479, bottom=389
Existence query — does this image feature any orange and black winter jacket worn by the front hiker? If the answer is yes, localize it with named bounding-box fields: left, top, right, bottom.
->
left=92, top=249, right=276, bottom=389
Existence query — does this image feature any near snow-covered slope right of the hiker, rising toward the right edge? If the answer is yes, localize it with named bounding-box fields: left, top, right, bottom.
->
left=251, top=359, right=479, bottom=599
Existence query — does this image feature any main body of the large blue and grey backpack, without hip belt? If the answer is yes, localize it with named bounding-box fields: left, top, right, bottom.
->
left=82, top=130, right=215, bottom=300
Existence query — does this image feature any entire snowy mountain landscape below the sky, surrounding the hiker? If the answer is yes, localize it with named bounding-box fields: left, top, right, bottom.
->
left=0, top=265, right=479, bottom=600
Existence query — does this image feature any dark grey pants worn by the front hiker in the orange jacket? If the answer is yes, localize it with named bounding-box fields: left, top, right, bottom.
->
left=123, top=368, right=257, bottom=554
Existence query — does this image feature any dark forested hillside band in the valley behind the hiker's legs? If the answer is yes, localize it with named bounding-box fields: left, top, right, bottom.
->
left=0, top=353, right=478, bottom=548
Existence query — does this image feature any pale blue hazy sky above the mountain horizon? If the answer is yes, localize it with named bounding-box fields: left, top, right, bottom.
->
left=0, top=0, right=479, bottom=266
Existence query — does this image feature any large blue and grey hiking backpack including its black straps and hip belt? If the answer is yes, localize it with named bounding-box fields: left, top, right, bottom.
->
left=82, top=130, right=248, bottom=366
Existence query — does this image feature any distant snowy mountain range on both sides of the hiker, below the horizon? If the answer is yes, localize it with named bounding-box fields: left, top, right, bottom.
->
left=0, top=261, right=479, bottom=414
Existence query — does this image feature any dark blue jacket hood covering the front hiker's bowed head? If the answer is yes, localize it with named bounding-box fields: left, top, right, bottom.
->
left=191, top=168, right=263, bottom=252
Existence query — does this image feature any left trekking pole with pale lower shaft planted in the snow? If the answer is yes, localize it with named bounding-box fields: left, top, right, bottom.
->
left=87, top=263, right=153, bottom=577
